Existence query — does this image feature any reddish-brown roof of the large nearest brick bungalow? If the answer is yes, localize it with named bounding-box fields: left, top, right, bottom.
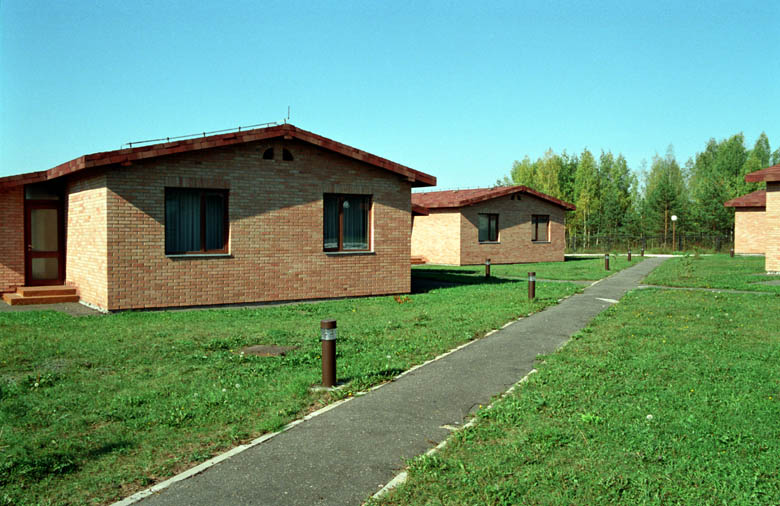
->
left=0, top=123, right=436, bottom=190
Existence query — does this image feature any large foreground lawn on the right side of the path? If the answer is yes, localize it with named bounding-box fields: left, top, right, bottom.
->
left=372, top=289, right=780, bottom=504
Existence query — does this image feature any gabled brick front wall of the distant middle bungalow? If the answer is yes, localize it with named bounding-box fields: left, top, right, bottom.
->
left=460, top=194, right=566, bottom=265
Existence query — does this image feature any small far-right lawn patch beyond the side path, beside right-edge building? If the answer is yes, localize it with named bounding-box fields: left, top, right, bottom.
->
left=644, top=255, right=780, bottom=293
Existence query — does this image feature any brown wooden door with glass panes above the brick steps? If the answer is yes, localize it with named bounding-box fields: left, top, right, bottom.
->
left=24, top=200, right=65, bottom=286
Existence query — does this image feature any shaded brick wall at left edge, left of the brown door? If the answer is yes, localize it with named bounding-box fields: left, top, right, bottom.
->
left=0, top=187, right=24, bottom=294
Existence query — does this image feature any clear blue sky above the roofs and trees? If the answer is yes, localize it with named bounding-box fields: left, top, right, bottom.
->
left=0, top=0, right=780, bottom=188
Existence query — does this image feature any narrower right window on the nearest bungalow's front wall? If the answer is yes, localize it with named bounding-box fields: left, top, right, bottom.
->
left=323, top=194, right=371, bottom=251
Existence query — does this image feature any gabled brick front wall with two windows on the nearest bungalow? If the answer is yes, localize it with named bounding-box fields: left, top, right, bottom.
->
left=107, top=140, right=411, bottom=309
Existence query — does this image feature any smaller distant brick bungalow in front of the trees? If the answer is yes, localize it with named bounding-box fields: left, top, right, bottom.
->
left=412, top=186, right=575, bottom=265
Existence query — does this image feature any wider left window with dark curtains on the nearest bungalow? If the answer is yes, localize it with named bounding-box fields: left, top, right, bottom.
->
left=165, top=188, right=228, bottom=255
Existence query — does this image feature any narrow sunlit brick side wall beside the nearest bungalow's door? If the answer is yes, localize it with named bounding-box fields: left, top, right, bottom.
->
left=65, top=175, right=109, bottom=309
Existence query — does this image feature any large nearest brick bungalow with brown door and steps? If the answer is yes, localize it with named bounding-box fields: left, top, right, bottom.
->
left=0, top=124, right=436, bottom=310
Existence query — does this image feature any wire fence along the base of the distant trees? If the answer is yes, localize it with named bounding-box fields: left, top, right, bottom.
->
left=566, top=233, right=734, bottom=253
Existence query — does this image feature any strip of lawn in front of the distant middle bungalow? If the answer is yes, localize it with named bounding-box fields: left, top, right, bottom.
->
left=412, top=255, right=643, bottom=283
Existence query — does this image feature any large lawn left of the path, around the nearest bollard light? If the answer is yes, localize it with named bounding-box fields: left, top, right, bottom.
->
left=0, top=282, right=578, bottom=504
